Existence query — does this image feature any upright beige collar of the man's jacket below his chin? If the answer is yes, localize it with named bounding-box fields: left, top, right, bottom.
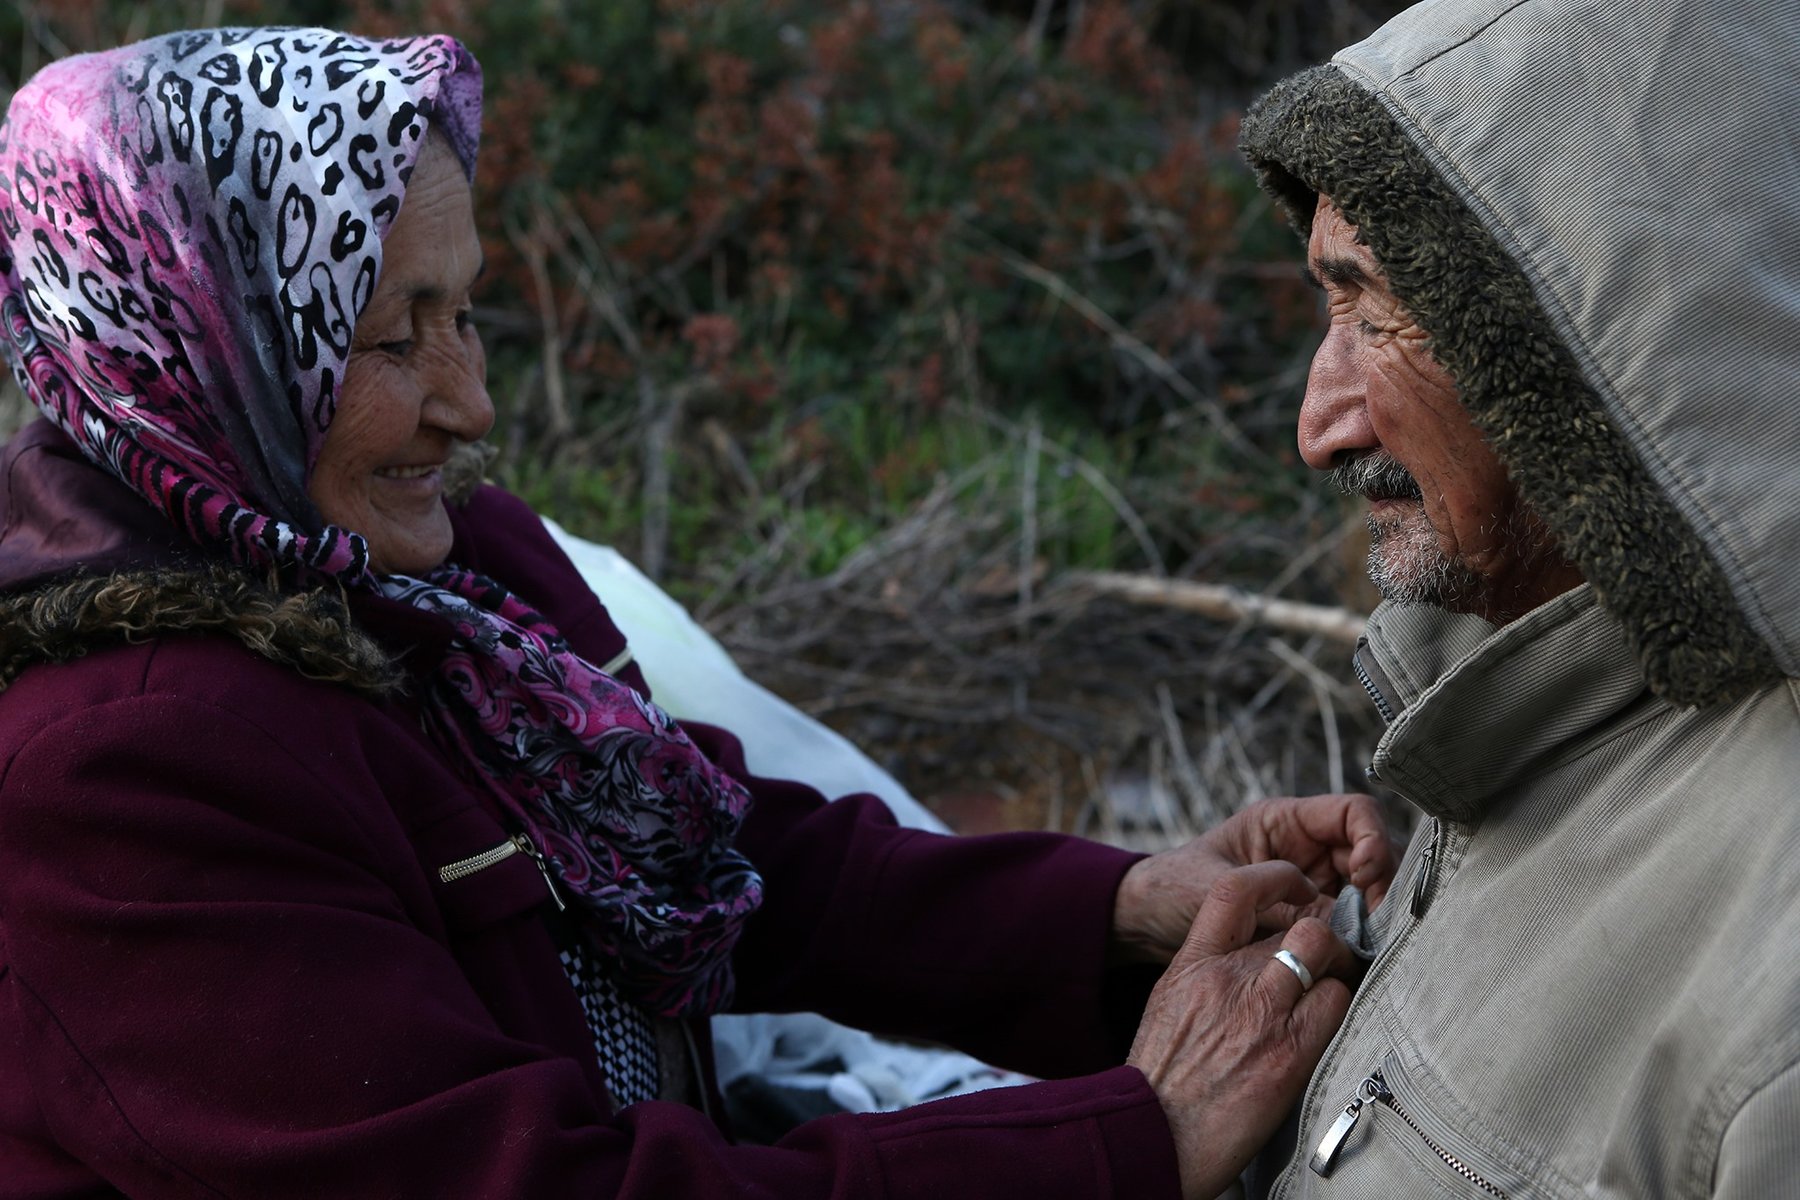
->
left=1357, top=585, right=1667, bottom=824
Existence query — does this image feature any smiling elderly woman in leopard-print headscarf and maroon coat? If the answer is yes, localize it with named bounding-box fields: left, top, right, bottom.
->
left=0, top=29, right=1391, bottom=1200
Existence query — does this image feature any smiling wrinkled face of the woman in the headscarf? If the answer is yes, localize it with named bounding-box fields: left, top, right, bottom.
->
left=306, top=135, right=493, bottom=574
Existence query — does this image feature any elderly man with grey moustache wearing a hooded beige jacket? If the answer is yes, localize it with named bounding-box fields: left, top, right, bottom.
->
left=1244, top=0, right=1800, bottom=1200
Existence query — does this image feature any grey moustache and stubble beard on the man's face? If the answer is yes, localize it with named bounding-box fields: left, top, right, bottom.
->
left=1330, top=452, right=1487, bottom=610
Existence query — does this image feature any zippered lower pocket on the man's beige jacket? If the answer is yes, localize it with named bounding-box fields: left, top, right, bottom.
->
left=1292, top=1052, right=1546, bottom=1200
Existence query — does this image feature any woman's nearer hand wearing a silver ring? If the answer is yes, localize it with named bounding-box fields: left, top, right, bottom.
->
left=1127, top=862, right=1361, bottom=1200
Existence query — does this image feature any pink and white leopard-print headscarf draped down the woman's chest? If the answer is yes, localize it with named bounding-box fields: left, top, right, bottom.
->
left=0, top=29, right=761, bottom=1015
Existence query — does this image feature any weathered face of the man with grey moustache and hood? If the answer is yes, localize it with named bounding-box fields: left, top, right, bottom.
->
left=1300, top=196, right=1580, bottom=624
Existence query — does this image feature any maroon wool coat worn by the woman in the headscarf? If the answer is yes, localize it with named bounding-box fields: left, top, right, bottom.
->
left=0, top=426, right=1177, bottom=1200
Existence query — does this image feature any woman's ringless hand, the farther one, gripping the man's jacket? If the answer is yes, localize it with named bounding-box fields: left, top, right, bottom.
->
left=1112, top=795, right=1395, bottom=963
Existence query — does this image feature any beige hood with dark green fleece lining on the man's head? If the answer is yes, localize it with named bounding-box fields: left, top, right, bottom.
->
left=1242, top=0, right=1800, bottom=703
